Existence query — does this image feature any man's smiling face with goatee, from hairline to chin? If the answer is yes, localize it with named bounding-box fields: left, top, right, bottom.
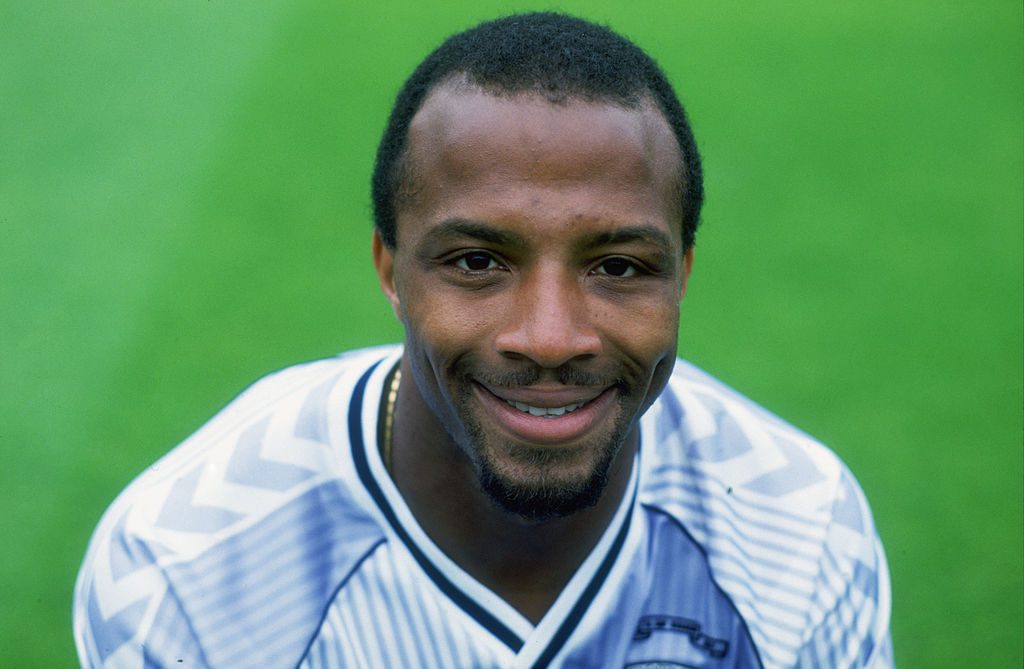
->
left=375, top=86, right=691, bottom=518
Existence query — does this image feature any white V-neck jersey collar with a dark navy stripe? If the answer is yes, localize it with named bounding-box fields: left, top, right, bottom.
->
left=348, top=349, right=643, bottom=666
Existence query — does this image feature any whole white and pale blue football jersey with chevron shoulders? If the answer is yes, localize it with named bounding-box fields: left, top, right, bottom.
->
left=74, top=346, right=892, bottom=669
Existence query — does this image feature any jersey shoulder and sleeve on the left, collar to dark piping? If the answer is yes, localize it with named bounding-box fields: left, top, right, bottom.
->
left=74, top=347, right=396, bottom=666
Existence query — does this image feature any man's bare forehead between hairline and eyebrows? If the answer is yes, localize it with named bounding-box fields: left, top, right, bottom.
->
left=398, top=85, right=680, bottom=242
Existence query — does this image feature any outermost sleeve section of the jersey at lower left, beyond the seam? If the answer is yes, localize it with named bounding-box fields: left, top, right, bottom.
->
left=74, top=514, right=209, bottom=669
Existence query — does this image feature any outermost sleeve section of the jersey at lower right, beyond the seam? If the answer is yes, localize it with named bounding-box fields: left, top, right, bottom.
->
left=797, top=467, right=894, bottom=669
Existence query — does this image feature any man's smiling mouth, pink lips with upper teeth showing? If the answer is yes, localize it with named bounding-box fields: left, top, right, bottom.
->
left=476, top=385, right=615, bottom=446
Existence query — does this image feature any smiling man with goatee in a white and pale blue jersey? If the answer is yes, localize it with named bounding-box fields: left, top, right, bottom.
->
left=75, top=14, right=891, bottom=668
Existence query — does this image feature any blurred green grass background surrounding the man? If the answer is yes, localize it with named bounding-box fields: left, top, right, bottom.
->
left=0, top=0, right=1024, bottom=668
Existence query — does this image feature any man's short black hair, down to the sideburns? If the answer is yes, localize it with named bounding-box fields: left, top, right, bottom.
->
left=373, top=12, right=703, bottom=251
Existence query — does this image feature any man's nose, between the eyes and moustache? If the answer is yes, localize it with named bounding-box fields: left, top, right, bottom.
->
left=495, top=268, right=601, bottom=369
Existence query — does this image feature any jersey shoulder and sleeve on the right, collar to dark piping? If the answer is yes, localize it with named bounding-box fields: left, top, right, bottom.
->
left=641, top=361, right=890, bottom=666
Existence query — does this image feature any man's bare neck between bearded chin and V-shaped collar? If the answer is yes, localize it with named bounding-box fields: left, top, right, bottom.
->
left=385, top=361, right=637, bottom=624
